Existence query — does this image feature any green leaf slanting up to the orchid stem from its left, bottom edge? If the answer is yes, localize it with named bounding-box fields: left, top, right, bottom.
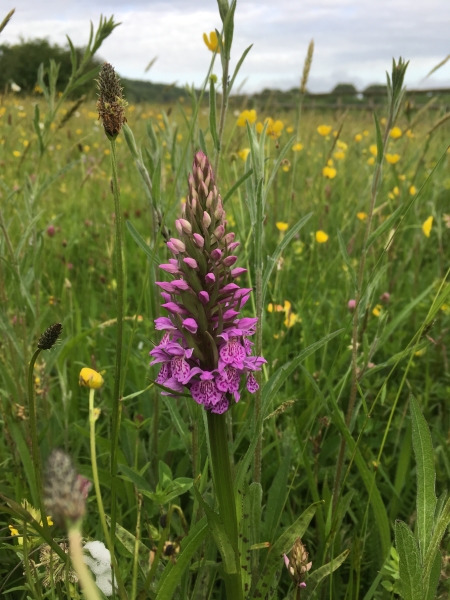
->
left=156, top=517, right=209, bottom=600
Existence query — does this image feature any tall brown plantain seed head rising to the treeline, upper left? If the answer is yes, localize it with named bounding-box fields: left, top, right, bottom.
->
left=97, top=63, right=128, bottom=140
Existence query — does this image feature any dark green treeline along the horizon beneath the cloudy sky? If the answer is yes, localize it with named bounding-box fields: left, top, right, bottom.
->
left=0, top=38, right=450, bottom=108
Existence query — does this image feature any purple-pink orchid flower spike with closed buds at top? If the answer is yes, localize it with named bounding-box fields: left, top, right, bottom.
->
left=150, top=152, right=265, bottom=414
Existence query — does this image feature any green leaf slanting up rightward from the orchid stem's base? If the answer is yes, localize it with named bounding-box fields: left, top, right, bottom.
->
left=251, top=502, right=323, bottom=598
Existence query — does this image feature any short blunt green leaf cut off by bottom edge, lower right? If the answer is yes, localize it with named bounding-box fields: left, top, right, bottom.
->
left=395, top=521, right=423, bottom=600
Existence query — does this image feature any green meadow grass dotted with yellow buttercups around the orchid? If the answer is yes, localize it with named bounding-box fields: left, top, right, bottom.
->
left=0, top=10, right=450, bottom=600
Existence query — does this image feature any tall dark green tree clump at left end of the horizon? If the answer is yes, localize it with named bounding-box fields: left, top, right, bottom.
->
left=0, top=39, right=102, bottom=96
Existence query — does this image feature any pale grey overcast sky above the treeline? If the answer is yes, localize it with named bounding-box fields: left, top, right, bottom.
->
left=0, top=0, right=450, bottom=92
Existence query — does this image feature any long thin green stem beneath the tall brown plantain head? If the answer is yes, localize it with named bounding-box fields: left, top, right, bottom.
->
left=110, top=139, right=124, bottom=555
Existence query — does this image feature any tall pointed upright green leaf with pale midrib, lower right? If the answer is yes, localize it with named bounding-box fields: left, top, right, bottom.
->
left=410, top=396, right=436, bottom=560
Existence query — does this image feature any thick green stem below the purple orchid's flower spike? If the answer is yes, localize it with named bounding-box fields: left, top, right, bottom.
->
left=207, top=411, right=244, bottom=600
